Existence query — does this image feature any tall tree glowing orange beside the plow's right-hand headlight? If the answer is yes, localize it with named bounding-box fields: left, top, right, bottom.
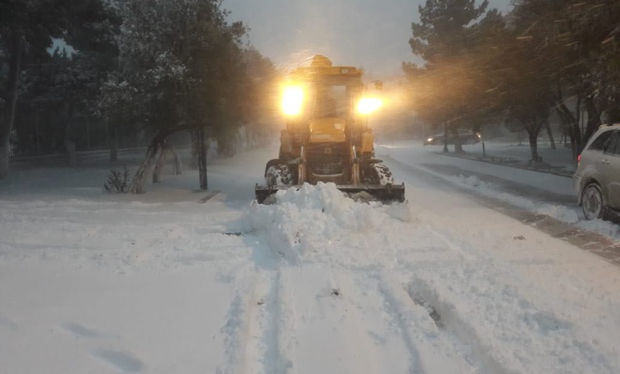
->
left=404, top=0, right=496, bottom=151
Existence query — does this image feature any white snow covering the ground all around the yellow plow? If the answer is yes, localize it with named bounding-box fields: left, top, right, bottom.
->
left=0, top=146, right=620, bottom=373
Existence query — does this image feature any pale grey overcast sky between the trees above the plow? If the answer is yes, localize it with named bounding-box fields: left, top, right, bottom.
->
left=223, top=0, right=510, bottom=77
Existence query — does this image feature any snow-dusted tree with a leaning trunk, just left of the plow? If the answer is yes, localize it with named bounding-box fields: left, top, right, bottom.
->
left=101, top=0, right=256, bottom=192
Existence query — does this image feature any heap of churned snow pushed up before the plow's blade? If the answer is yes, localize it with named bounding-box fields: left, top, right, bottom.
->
left=242, top=183, right=410, bottom=263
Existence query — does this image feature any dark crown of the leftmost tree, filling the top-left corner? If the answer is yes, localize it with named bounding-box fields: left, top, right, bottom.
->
left=0, top=0, right=112, bottom=172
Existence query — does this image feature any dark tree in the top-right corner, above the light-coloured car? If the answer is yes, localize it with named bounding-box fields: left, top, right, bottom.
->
left=511, top=0, right=620, bottom=159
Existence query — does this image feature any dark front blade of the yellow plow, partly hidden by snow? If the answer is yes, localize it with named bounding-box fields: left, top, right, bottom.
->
left=255, top=183, right=405, bottom=204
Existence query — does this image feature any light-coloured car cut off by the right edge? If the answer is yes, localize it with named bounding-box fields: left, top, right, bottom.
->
left=573, top=124, right=620, bottom=220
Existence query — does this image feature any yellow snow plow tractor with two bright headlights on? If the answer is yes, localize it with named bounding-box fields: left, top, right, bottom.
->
left=256, top=55, right=405, bottom=203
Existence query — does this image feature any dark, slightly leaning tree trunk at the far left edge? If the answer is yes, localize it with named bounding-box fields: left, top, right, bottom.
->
left=0, top=32, right=24, bottom=179
